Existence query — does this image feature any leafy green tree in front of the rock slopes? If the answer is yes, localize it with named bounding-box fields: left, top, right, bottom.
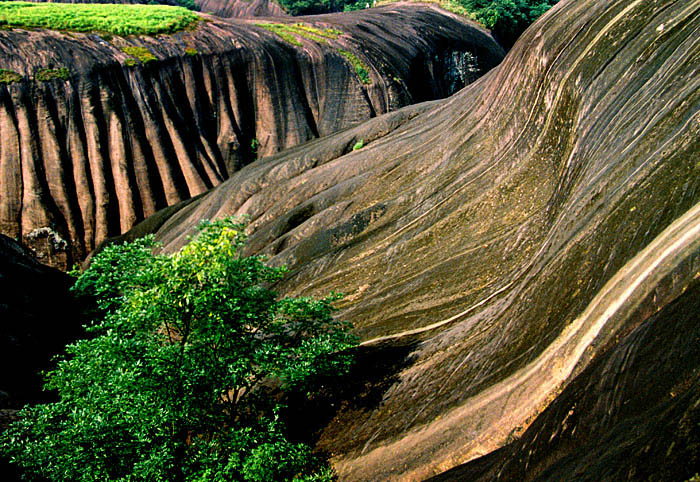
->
left=0, top=219, right=357, bottom=482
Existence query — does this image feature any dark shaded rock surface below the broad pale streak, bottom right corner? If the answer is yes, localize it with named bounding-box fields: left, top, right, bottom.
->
left=430, top=274, right=700, bottom=482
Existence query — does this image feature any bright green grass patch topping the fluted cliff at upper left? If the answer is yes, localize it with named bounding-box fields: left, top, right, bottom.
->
left=0, top=1, right=199, bottom=35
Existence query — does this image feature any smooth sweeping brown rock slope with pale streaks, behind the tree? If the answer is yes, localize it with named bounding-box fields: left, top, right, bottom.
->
left=121, top=0, right=700, bottom=481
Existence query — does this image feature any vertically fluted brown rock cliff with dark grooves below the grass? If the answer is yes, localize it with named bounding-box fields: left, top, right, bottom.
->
left=0, top=6, right=503, bottom=268
